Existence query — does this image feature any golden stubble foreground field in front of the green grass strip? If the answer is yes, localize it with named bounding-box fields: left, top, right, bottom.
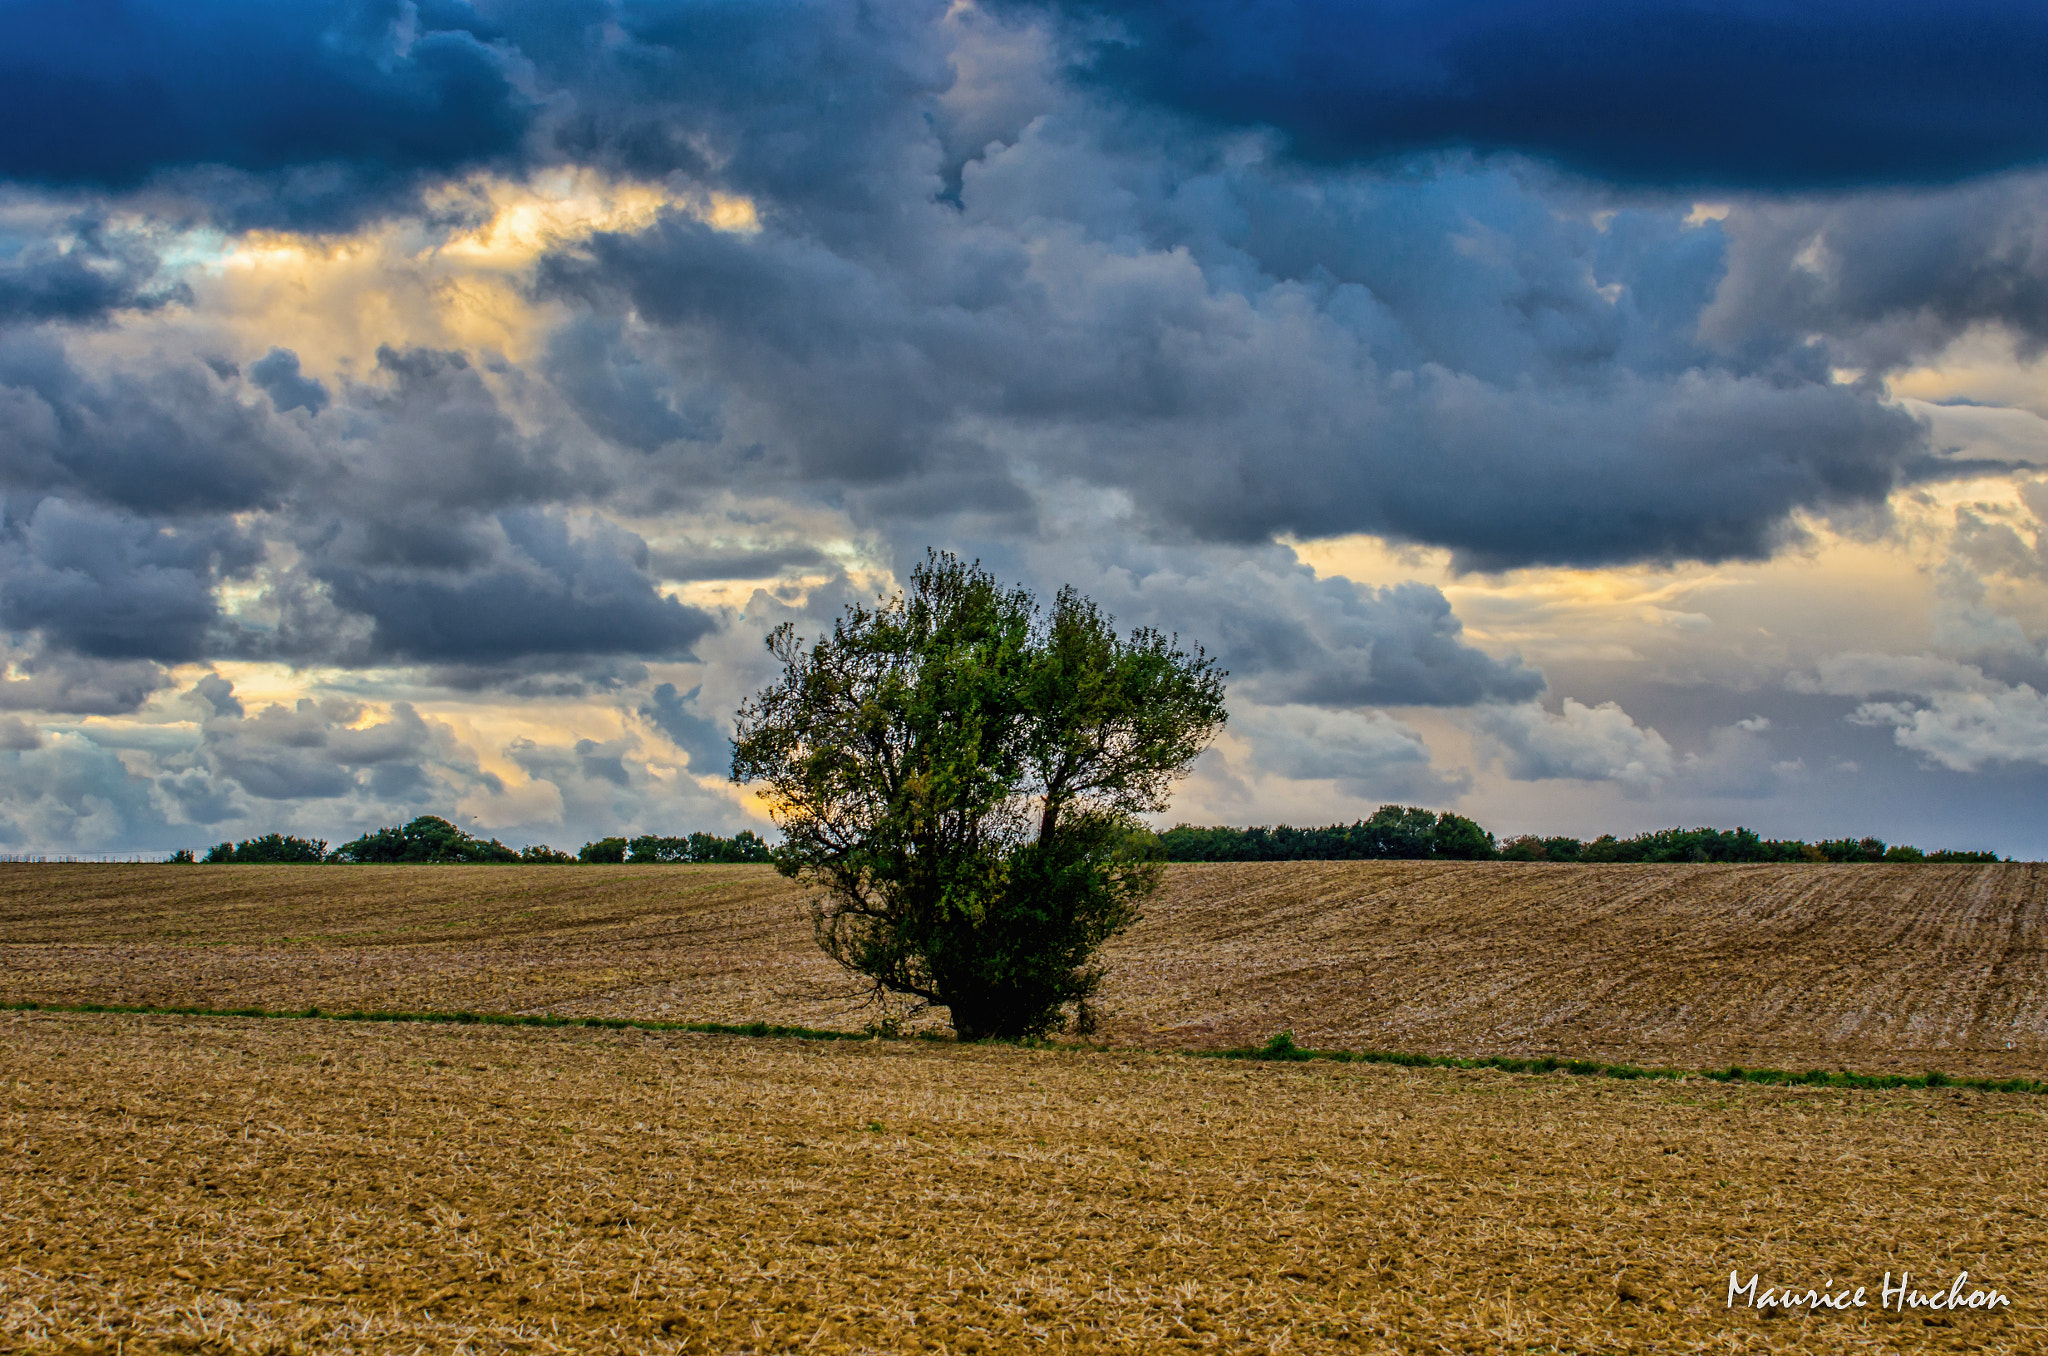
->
left=0, top=1012, right=2048, bottom=1354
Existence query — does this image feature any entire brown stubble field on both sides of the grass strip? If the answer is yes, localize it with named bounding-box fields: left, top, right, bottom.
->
left=0, top=864, right=2048, bottom=1354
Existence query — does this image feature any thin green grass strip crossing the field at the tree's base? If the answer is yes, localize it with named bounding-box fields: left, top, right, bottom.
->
left=16, top=1004, right=2048, bottom=1094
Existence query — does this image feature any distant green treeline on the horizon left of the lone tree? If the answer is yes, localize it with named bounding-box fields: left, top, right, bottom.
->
left=170, top=815, right=768, bottom=866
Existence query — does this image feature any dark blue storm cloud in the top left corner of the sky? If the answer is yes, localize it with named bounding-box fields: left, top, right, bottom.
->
left=0, top=0, right=532, bottom=225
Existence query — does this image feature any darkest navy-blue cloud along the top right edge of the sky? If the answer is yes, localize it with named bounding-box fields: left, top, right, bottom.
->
left=1048, top=0, right=2048, bottom=188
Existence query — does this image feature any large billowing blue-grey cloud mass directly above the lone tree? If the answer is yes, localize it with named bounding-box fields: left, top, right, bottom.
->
left=543, top=134, right=1929, bottom=567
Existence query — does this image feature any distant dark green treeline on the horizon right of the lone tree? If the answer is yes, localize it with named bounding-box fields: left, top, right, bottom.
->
left=1159, top=805, right=1999, bottom=862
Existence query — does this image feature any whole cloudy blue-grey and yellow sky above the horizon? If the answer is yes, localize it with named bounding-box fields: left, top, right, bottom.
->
left=0, top=0, right=2048, bottom=856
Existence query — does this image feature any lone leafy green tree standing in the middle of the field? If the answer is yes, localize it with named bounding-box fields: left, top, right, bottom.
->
left=733, top=551, right=1227, bottom=1041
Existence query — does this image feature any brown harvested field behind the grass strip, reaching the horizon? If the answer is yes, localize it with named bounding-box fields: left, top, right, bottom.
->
left=0, top=862, right=2048, bottom=1077
